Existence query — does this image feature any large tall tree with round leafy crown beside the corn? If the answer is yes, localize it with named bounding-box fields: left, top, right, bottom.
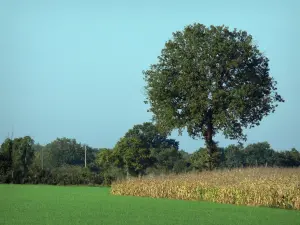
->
left=143, top=24, right=283, bottom=170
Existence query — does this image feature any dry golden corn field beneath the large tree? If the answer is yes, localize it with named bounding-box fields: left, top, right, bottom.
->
left=111, top=168, right=300, bottom=210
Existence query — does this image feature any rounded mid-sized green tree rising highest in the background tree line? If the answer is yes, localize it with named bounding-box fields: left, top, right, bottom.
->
left=111, top=122, right=181, bottom=176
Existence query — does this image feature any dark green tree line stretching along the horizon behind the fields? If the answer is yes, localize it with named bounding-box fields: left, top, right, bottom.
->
left=0, top=122, right=300, bottom=185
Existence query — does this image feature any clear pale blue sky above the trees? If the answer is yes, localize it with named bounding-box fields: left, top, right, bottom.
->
left=0, top=0, right=300, bottom=152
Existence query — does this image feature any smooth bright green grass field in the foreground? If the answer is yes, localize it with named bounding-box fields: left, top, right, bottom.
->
left=0, top=185, right=300, bottom=225
